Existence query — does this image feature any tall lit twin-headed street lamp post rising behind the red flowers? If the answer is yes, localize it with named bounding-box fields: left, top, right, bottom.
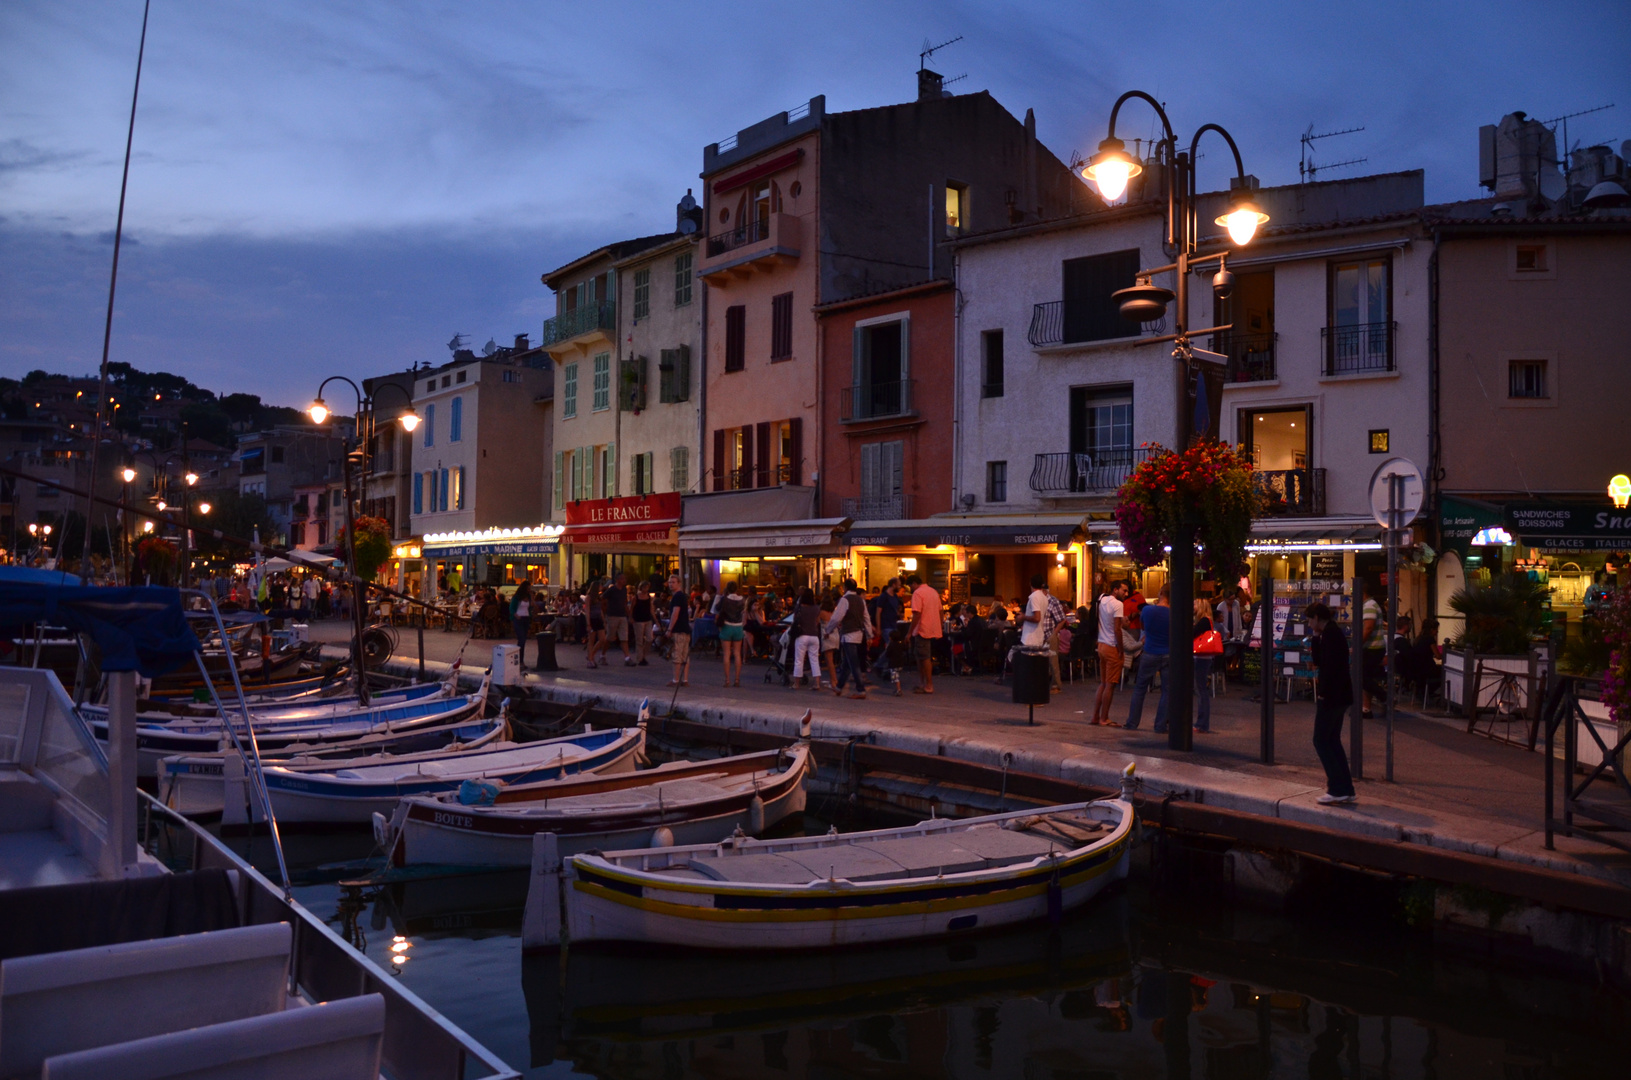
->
left=1081, top=90, right=1269, bottom=750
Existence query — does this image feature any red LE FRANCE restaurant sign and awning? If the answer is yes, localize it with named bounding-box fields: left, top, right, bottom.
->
left=561, top=491, right=680, bottom=586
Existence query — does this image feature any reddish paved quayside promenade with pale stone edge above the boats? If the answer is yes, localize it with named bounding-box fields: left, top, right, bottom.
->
left=312, top=622, right=1631, bottom=889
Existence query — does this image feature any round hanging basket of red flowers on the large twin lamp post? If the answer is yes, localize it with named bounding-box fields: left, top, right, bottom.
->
left=1116, top=439, right=1262, bottom=582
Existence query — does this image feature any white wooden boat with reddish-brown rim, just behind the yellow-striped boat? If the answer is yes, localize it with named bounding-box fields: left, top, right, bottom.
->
left=382, top=744, right=811, bottom=866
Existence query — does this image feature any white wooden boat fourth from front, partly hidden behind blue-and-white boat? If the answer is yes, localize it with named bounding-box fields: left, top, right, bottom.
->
left=158, top=716, right=509, bottom=821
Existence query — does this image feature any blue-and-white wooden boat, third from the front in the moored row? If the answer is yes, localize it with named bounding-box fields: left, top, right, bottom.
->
left=263, top=728, right=646, bottom=824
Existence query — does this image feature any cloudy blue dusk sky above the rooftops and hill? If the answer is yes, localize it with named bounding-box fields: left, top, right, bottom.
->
left=0, top=0, right=1631, bottom=405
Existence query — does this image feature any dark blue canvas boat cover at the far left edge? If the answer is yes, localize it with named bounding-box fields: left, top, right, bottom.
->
left=0, top=566, right=201, bottom=679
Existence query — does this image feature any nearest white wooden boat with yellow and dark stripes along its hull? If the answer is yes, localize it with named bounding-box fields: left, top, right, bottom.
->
left=522, top=786, right=1137, bottom=949
